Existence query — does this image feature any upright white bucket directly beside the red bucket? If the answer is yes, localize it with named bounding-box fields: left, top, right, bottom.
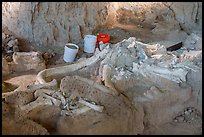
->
left=84, top=35, right=97, bottom=53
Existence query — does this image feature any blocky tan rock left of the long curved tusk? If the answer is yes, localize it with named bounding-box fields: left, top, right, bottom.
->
left=13, top=52, right=46, bottom=72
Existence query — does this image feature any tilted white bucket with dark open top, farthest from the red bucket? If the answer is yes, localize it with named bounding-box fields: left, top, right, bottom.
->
left=64, top=43, right=79, bottom=63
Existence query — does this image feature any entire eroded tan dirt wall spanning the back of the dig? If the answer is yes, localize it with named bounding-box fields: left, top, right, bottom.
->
left=2, top=2, right=202, bottom=52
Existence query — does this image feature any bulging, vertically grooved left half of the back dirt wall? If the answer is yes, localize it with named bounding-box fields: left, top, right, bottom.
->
left=2, top=2, right=109, bottom=52
